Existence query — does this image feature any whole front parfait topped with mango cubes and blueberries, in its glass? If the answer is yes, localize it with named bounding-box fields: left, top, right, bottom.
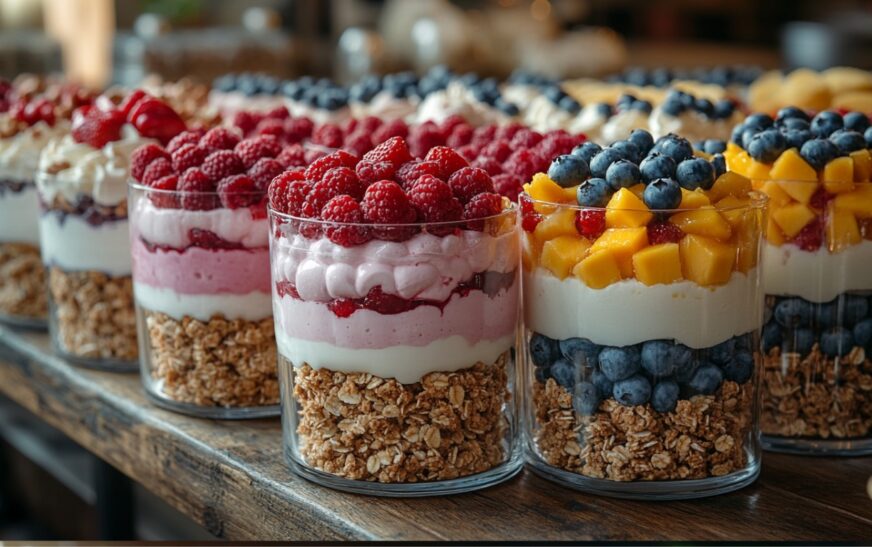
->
left=520, top=130, right=765, bottom=498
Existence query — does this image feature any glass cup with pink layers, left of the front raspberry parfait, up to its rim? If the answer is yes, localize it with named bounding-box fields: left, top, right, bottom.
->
left=129, top=182, right=280, bottom=419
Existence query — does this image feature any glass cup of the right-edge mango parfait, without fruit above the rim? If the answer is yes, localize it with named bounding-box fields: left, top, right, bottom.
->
left=755, top=180, right=872, bottom=455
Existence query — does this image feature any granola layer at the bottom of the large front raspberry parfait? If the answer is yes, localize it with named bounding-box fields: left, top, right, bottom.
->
left=290, top=352, right=510, bottom=483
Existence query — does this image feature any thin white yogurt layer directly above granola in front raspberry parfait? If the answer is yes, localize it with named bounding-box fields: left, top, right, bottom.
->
left=276, top=329, right=515, bottom=384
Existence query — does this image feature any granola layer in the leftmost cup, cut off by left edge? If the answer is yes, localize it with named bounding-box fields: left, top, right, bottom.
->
left=0, top=243, right=48, bottom=319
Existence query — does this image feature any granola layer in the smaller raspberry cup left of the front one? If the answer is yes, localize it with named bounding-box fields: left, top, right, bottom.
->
left=144, top=310, right=279, bottom=408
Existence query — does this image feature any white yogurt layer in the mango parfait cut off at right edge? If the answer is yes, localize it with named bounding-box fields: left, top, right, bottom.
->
left=763, top=240, right=872, bottom=302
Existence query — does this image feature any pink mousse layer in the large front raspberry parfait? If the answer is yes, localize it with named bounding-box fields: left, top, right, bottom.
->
left=273, top=277, right=520, bottom=349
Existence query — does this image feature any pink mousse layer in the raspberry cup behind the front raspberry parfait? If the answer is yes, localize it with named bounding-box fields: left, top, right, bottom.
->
left=132, top=237, right=270, bottom=294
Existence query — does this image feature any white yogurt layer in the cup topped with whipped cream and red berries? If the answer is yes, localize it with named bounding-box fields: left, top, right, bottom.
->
left=39, top=213, right=132, bottom=277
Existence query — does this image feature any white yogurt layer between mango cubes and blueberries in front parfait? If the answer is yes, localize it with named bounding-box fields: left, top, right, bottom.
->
left=524, top=268, right=763, bottom=349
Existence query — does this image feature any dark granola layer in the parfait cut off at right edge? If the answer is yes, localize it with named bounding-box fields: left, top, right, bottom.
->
left=760, top=344, right=872, bottom=439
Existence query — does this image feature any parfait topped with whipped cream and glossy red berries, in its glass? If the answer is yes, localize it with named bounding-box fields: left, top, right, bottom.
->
left=36, top=92, right=185, bottom=370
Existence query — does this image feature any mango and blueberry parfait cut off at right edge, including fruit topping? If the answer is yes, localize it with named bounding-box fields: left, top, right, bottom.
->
left=725, top=108, right=872, bottom=454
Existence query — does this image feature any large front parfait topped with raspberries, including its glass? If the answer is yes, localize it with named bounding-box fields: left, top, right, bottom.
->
left=270, top=137, right=520, bottom=495
